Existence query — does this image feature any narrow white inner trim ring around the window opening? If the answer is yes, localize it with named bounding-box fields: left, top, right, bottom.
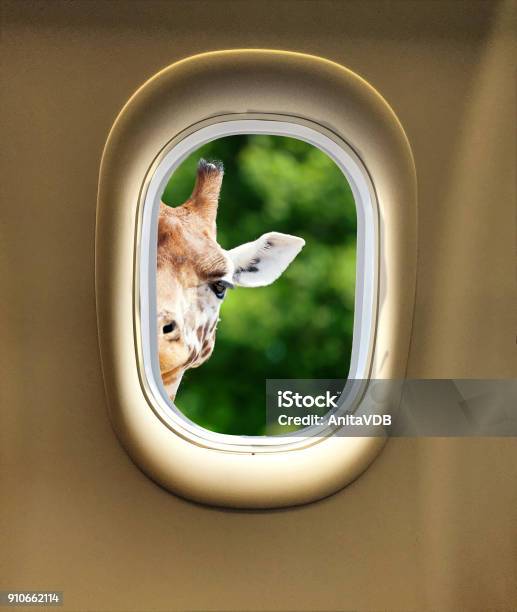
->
left=135, top=115, right=379, bottom=453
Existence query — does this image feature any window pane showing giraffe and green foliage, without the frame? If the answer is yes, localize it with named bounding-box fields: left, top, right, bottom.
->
left=157, top=134, right=356, bottom=435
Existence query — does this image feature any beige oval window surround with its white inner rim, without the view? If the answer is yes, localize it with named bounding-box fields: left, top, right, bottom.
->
left=96, top=50, right=416, bottom=508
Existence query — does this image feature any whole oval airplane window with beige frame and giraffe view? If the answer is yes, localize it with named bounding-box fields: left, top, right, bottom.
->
left=95, top=50, right=418, bottom=508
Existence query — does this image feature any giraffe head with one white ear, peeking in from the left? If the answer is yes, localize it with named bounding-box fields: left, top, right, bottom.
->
left=157, top=159, right=305, bottom=399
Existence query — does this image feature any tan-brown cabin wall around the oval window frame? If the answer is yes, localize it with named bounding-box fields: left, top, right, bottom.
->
left=0, top=0, right=517, bottom=611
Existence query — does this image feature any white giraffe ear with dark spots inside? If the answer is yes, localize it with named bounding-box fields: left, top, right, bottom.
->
left=228, top=232, right=305, bottom=287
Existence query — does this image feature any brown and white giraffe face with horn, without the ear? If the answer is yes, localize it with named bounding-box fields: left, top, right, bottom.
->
left=157, top=160, right=233, bottom=399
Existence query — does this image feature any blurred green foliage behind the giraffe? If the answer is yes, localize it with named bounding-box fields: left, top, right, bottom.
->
left=163, top=135, right=356, bottom=435
